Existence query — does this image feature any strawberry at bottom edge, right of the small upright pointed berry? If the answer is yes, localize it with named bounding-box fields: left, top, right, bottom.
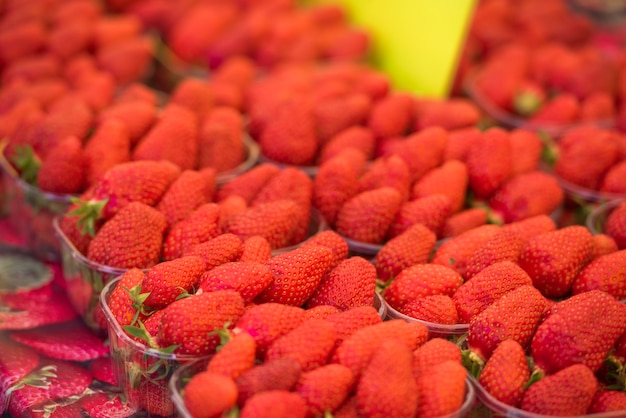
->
left=520, top=364, right=598, bottom=416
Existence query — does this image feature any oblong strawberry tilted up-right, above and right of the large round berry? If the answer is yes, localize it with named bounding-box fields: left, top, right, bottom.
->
left=156, top=170, right=216, bottom=227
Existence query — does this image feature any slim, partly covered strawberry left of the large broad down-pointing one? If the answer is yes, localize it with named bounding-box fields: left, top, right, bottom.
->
left=431, top=224, right=500, bottom=276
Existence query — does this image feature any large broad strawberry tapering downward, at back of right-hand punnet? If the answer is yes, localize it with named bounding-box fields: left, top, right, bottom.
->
left=519, top=225, right=595, bottom=298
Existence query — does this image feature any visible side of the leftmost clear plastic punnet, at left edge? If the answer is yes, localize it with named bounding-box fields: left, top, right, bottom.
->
left=0, top=147, right=71, bottom=262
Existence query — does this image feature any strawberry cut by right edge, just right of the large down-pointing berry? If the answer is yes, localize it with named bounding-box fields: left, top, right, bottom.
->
left=572, top=250, right=626, bottom=300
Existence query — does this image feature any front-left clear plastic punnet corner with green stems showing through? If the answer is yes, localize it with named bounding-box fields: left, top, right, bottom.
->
left=100, top=277, right=208, bottom=417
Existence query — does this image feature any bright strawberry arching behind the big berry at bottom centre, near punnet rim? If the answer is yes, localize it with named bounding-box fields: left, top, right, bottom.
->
left=330, top=319, right=428, bottom=379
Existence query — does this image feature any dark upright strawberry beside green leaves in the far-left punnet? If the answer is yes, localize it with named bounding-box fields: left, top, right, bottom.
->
left=37, top=136, right=87, bottom=194
